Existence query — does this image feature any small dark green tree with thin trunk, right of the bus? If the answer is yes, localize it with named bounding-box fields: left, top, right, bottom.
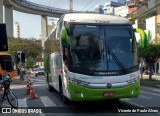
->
left=139, top=43, right=160, bottom=80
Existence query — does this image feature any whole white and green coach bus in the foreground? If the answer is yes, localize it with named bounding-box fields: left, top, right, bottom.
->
left=44, top=13, right=140, bottom=102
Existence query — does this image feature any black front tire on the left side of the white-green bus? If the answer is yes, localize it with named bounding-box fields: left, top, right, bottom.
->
left=59, top=78, right=69, bottom=105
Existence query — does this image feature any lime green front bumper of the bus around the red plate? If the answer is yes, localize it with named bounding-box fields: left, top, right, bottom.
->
left=69, top=81, right=140, bottom=101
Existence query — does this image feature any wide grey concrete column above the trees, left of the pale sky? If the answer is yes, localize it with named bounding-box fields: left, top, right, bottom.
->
left=5, top=5, right=13, bottom=37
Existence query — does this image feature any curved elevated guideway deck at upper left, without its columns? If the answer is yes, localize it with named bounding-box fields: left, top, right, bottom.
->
left=3, top=0, right=68, bottom=18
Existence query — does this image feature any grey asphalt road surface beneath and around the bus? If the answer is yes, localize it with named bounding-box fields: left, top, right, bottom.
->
left=1, top=76, right=160, bottom=116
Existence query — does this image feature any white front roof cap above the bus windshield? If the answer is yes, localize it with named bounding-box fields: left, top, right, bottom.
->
left=63, top=13, right=131, bottom=24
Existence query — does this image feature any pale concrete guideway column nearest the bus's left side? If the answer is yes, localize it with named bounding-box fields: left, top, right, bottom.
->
left=41, top=15, right=48, bottom=58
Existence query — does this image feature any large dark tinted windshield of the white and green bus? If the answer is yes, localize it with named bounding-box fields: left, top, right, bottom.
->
left=69, top=24, right=138, bottom=71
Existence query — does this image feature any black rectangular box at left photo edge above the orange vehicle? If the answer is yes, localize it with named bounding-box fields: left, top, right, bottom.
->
left=0, top=24, right=8, bottom=51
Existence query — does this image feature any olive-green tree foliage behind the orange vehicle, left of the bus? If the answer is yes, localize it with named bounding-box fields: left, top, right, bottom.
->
left=8, top=38, right=42, bottom=68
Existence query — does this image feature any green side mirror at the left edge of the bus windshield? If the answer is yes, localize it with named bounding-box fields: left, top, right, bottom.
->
left=60, top=26, right=68, bottom=48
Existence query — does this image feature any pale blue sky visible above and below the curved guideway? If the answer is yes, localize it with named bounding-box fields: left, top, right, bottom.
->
left=13, top=0, right=125, bottom=39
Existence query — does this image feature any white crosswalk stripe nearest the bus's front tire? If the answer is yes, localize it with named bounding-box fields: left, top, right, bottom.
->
left=40, top=96, right=56, bottom=107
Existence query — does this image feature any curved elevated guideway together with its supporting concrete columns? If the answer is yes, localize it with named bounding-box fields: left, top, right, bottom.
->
left=0, top=0, right=73, bottom=39
